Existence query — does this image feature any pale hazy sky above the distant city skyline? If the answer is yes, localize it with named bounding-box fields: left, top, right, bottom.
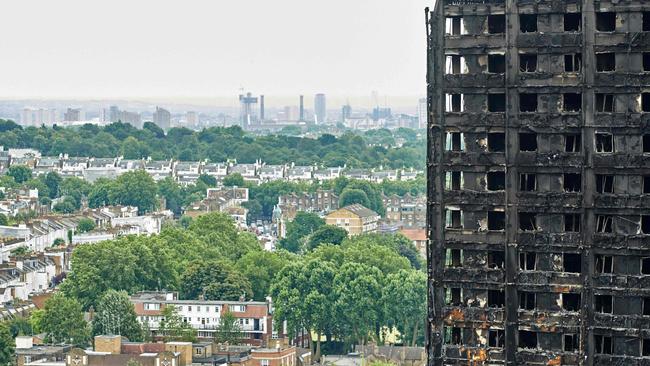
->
left=0, top=0, right=432, bottom=106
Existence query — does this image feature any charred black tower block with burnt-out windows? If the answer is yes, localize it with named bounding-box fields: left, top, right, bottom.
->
left=426, top=0, right=650, bottom=366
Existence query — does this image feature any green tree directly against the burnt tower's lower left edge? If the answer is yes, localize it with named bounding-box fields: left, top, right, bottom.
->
left=381, top=270, right=427, bottom=346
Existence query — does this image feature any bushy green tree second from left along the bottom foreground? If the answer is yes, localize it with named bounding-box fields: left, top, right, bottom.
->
left=40, top=293, right=90, bottom=347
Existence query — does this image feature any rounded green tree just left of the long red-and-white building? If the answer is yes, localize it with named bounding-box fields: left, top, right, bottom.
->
left=93, top=290, right=142, bottom=341
